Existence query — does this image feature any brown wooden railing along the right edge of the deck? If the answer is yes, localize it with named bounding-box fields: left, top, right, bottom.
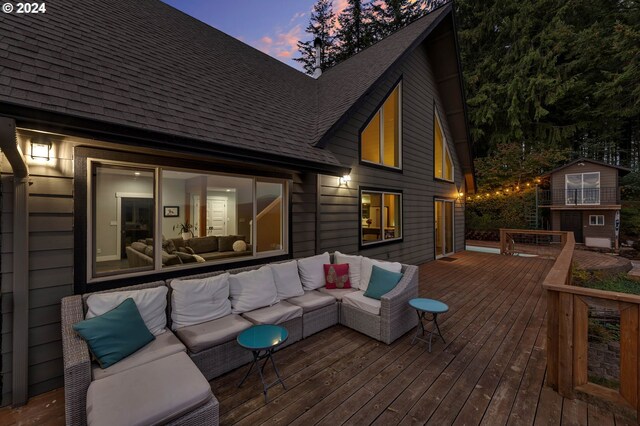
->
left=500, top=229, right=640, bottom=418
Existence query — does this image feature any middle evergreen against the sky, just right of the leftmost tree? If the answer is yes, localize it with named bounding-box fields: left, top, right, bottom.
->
left=336, top=0, right=373, bottom=62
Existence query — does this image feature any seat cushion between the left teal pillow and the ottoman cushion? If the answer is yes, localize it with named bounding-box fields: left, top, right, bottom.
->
left=91, top=330, right=187, bottom=380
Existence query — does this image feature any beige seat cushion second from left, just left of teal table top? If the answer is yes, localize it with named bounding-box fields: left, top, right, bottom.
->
left=176, top=314, right=253, bottom=353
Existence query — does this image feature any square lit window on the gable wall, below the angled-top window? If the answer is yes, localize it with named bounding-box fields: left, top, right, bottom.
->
left=360, top=190, right=402, bottom=245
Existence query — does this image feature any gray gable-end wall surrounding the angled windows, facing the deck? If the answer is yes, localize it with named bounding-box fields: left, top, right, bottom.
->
left=317, top=45, right=465, bottom=264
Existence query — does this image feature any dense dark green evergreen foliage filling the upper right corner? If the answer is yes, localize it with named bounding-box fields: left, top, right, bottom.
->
left=456, top=0, right=640, bottom=181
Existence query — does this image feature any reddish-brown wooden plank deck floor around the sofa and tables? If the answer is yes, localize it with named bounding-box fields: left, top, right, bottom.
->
left=0, top=252, right=636, bottom=426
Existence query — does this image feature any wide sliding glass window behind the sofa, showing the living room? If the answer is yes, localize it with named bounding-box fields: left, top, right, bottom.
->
left=88, top=160, right=288, bottom=280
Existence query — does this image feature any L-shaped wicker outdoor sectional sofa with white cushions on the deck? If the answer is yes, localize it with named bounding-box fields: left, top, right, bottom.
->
left=62, top=252, right=418, bottom=425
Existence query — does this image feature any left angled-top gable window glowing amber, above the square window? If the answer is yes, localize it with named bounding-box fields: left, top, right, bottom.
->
left=360, top=83, right=402, bottom=169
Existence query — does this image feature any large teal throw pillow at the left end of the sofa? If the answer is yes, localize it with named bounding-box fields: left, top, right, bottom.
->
left=73, top=298, right=155, bottom=368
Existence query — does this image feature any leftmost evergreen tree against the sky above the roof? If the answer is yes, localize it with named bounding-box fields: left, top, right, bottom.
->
left=294, top=0, right=336, bottom=74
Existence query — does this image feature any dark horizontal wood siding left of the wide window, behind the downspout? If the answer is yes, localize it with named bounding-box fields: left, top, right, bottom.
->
left=1, top=137, right=73, bottom=405
